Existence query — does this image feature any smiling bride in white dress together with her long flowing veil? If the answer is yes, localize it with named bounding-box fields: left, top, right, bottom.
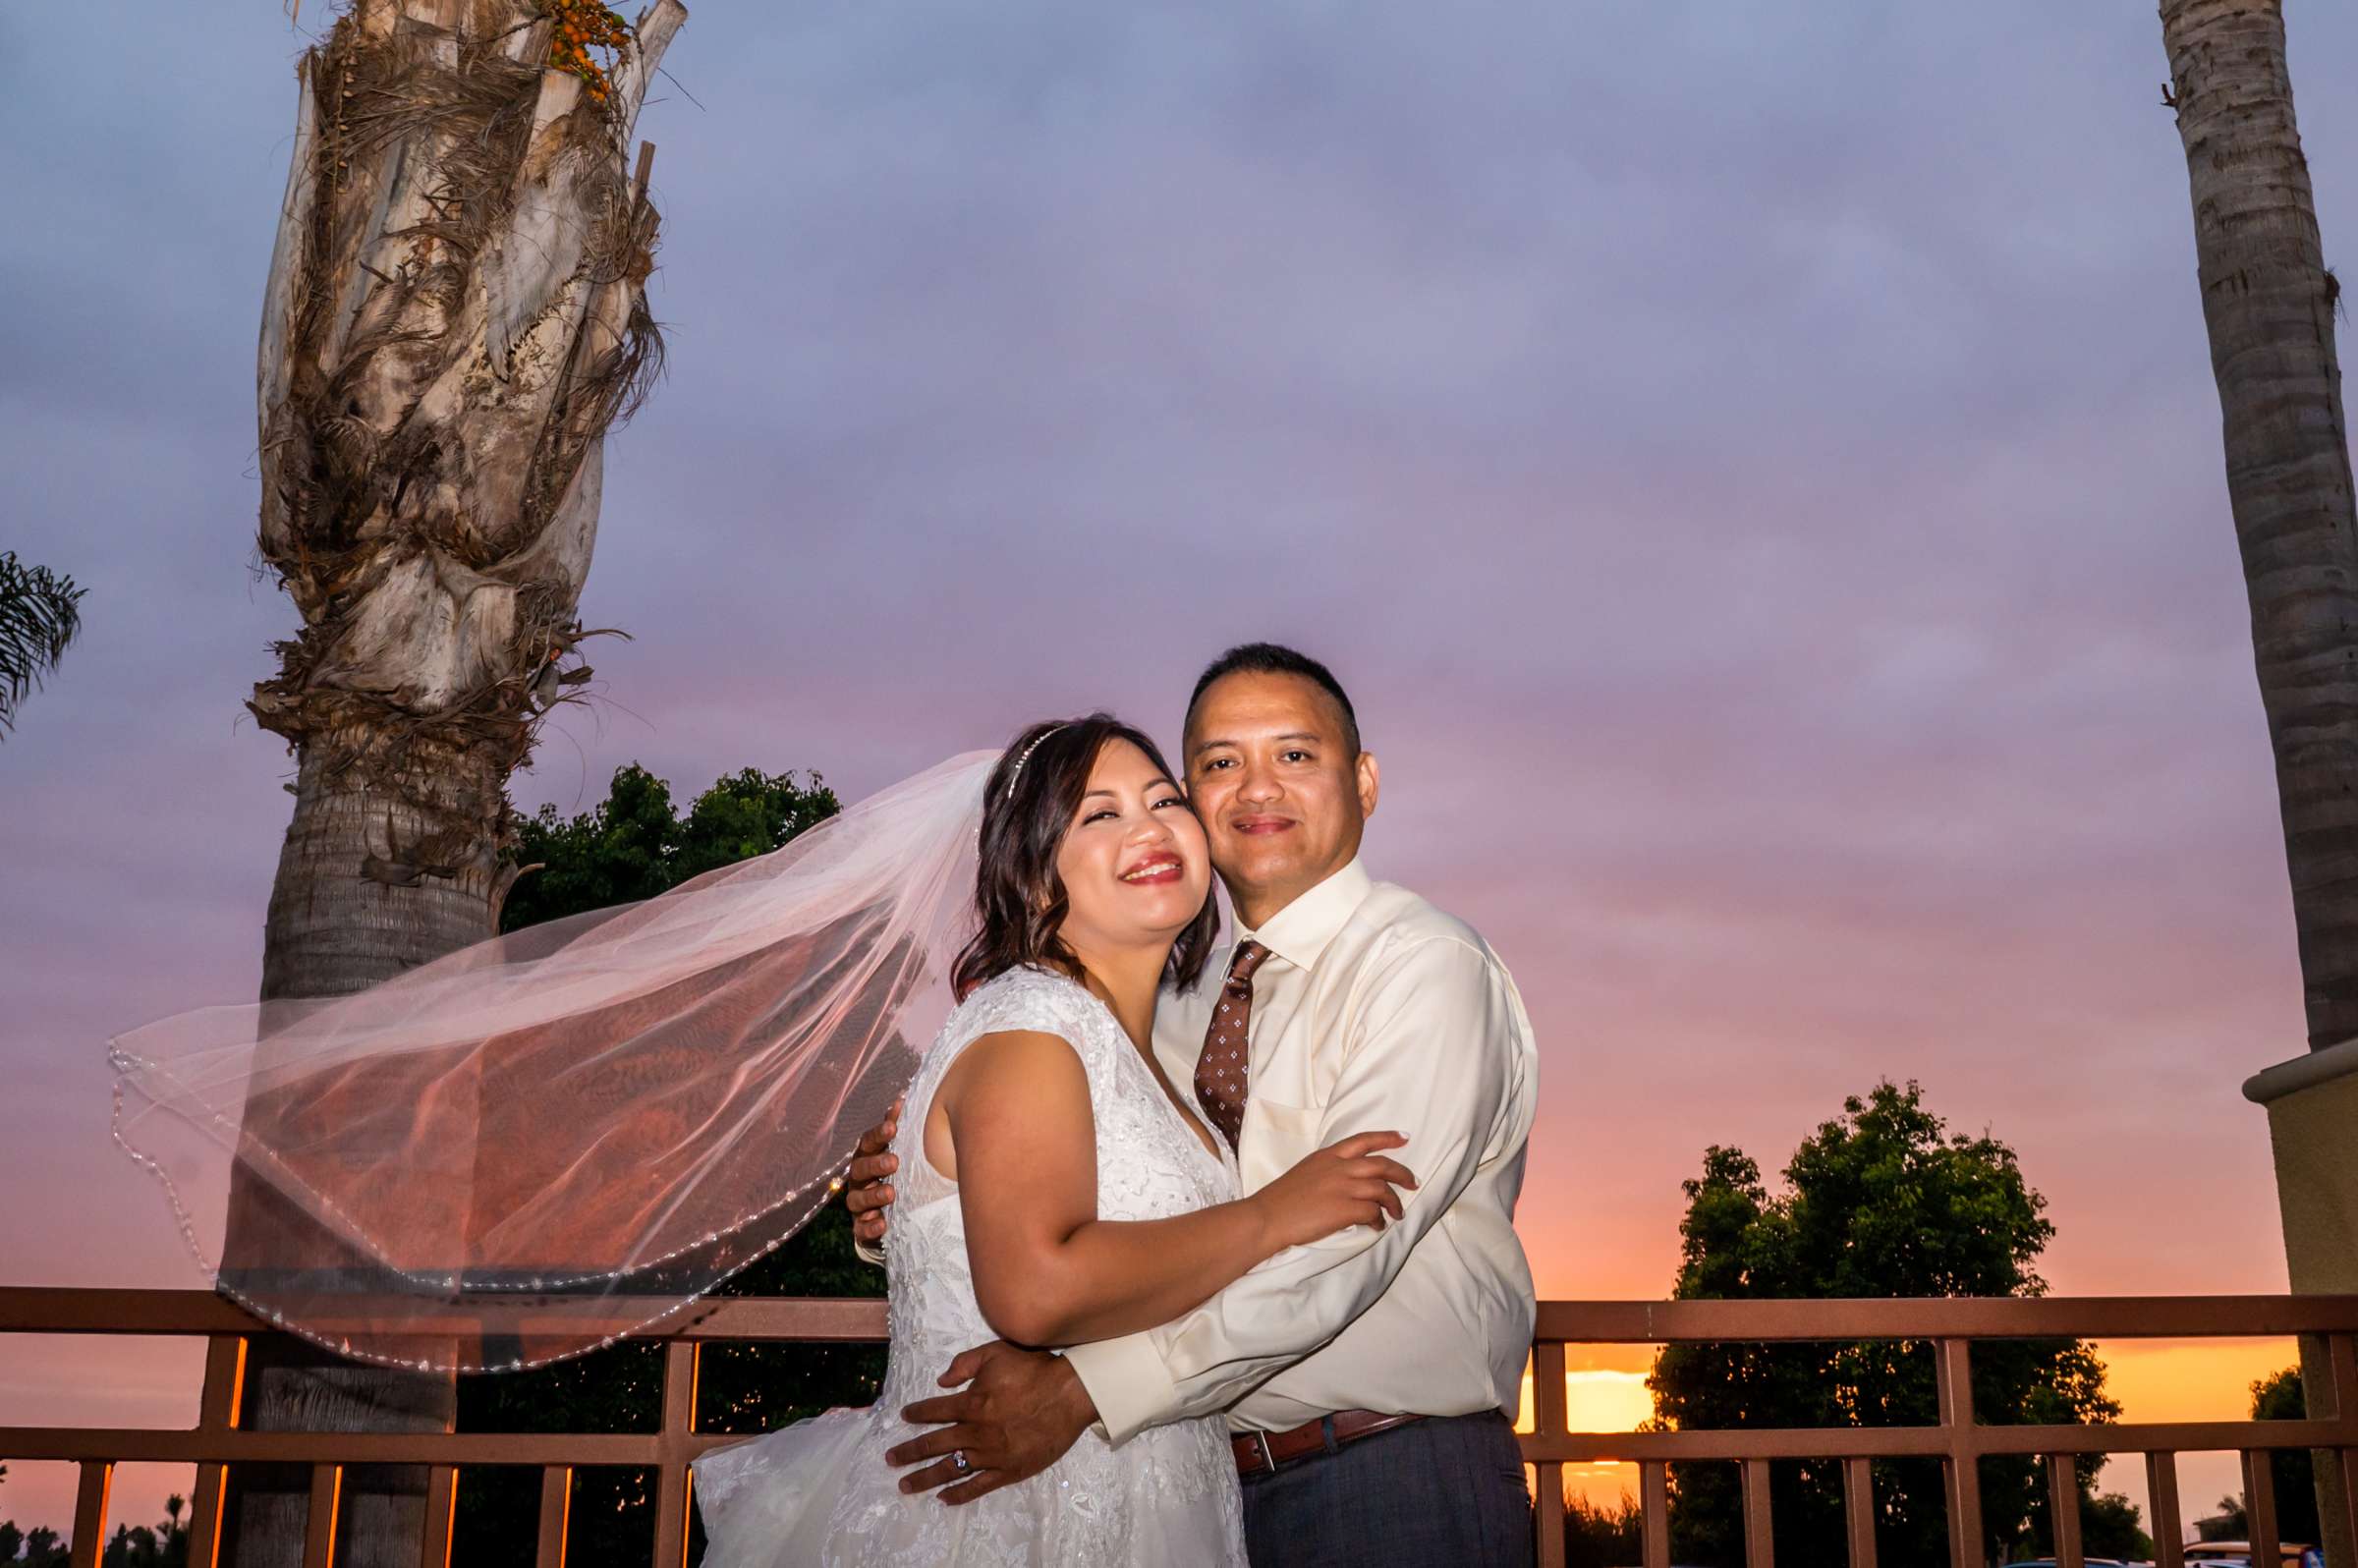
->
left=111, top=714, right=1415, bottom=1568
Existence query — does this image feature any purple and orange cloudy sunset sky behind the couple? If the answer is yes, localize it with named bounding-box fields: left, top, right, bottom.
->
left=0, top=0, right=2358, bottom=1526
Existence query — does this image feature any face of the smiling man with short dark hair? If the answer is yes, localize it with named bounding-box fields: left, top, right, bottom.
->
left=1186, top=672, right=1377, bottom=926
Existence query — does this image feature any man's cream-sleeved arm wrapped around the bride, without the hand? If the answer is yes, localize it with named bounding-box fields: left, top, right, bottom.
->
left=1066, top=936, right=1521, bottom=1443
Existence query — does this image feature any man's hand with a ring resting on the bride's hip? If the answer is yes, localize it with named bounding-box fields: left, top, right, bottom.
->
left=884, top=1339, right=1096, bottom=1502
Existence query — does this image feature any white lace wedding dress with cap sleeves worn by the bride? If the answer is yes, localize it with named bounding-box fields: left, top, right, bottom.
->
left=696, top=969, right=1245, bottom=1568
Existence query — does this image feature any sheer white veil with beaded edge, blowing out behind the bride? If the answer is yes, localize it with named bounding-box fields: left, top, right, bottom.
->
left=108, top=753, right=1000, bottom=1372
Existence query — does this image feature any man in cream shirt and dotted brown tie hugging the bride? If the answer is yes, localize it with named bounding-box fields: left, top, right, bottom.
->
left=847, top=644, right=1538, bottom=1568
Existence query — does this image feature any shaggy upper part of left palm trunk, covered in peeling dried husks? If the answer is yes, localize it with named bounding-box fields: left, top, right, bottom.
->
left=250, top=0, right=686, bottom=844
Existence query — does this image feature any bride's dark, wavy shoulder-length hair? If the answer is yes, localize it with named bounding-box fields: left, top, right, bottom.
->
left=950, top=712, right=1219, bottom=997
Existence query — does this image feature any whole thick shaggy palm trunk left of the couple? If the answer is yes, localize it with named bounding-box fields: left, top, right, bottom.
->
left=224, top=0, right=686, bottom=1568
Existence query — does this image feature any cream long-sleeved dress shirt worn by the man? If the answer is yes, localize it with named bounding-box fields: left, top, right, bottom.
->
left=1066, top=861, right=1540, bottom=1443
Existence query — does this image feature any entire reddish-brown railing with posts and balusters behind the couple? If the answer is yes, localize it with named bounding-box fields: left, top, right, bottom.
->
left=0, top=1287, right=2358, bottom=1568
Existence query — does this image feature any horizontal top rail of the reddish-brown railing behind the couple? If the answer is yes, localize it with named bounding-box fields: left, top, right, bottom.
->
left=0, top=1285, right=2358, bottom=1344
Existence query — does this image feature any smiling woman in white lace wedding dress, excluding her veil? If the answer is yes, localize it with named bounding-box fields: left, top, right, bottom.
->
left=696, top=714, right=1415, bottom=1568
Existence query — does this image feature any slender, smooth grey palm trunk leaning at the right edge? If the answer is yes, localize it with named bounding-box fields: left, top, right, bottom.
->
left=2162, top=0, right=2358, bottom=1568
